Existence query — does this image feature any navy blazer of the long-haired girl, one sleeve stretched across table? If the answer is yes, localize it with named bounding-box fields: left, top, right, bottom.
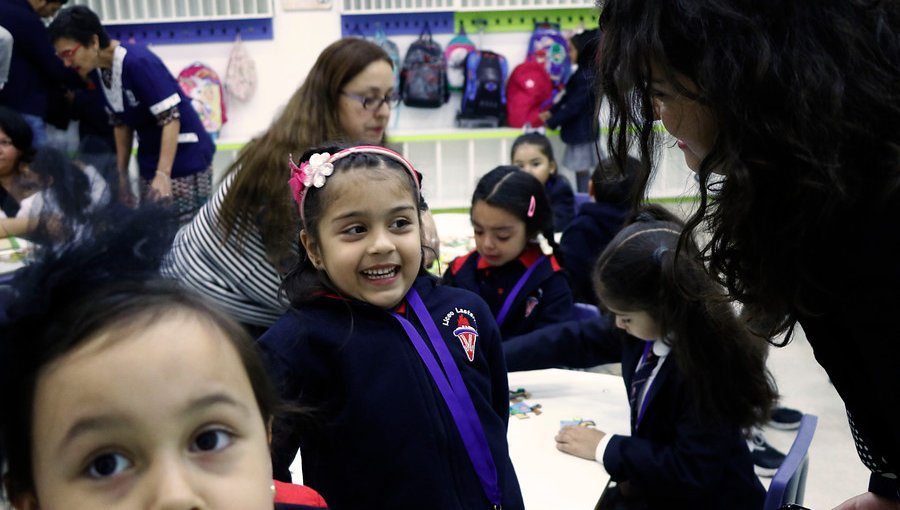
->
left=503, top=316, right=765, bottom=510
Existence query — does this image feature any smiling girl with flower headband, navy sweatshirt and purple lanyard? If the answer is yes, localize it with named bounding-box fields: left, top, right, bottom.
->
left=259, top=146, right=523, bottom=510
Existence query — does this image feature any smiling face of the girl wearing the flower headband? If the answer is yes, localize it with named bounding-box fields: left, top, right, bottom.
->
left=300, top=168, right=422, bottom=308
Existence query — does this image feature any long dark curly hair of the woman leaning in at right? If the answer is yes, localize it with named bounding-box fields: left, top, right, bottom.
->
left=600, top=0, right=900, bottom=342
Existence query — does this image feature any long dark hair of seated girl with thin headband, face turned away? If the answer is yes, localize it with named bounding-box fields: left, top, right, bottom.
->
left=593, top=206, right=777, bottom=427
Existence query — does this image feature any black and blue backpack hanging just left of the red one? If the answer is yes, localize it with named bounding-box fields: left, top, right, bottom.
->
left=456, top=50, right=508, bottom=127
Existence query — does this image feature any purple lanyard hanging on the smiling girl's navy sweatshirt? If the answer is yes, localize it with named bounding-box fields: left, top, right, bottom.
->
left=392, top=288, right=501, bottom=510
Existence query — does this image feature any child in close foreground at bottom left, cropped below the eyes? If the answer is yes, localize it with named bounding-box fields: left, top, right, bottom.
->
left=0, top=207, right=325, bottom=510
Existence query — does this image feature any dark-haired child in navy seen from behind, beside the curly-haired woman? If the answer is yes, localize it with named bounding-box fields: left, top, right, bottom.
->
left=559, top=157, right=640, bottom=305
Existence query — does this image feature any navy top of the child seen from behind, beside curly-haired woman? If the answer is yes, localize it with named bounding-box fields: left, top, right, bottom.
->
left=559, top=198, right=628, bottom=305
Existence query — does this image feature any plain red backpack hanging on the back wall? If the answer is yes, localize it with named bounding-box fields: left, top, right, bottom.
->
left=506, top=61, right=553, bottom=128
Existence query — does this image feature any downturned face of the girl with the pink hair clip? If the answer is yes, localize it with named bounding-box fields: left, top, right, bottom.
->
left=472, top=200, right=528, bottom=267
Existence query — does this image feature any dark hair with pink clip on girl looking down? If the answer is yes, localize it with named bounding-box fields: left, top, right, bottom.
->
left=472, top=165, right=559, bottom=253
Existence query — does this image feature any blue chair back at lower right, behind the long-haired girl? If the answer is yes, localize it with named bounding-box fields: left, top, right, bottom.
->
left=763, top=414, right=819, bottom=510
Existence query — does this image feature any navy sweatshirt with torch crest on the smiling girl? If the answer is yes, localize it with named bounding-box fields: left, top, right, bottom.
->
left=259, top=276, right=524, bottom=510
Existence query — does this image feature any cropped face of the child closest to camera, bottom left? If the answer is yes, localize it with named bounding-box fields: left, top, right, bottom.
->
left=24, top=313, right=273, bottom=510
